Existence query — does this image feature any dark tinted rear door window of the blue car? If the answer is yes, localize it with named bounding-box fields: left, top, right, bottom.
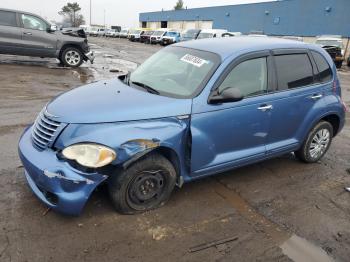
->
left=275, top=53, right=314, bottom=90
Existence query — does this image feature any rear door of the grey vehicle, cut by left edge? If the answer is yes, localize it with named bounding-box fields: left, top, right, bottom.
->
left=0, top=10, right=22, bottom=55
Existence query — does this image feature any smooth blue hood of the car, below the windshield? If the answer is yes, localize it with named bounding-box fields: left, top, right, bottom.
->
left=46, top=79, right=192, bottom=124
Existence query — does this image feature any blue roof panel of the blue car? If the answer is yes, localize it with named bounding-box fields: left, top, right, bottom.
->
left=174, top=36, right=310, bottom=60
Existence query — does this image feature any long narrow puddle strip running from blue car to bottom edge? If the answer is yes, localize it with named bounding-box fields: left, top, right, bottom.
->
left=214, top=181, right=334, bottom=262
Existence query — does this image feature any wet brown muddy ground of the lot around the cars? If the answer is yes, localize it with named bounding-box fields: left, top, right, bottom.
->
left=0, top=38, right=350, bottom=262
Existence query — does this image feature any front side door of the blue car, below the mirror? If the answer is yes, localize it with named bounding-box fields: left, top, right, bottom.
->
left=191, top=52, right=274, bottom=176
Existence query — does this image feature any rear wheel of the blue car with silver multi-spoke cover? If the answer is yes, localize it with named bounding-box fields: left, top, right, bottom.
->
left=294, top=121, right=333, bottom=163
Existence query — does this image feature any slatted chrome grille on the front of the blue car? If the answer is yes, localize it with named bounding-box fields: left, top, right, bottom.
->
left=32, top=109, right=61, bottom=150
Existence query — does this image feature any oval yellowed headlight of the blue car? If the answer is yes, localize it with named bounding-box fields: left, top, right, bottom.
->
left=62, top=144, right=117, bottom=168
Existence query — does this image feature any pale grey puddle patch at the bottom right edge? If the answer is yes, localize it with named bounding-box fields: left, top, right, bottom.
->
left=280, top=235, right=334, bottom=262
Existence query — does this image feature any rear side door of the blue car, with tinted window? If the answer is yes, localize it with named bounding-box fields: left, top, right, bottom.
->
left=266, top=49, right=324, bottom=155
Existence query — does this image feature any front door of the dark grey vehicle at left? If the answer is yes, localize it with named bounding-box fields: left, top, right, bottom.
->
left=20, top=14, right=57, bottom=57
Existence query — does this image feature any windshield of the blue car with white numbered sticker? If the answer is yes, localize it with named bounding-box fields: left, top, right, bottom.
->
left=129, top=47, right=220, bottom=98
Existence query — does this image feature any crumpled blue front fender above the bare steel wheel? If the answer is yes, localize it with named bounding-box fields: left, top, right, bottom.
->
left=55, top=116, right=190, bottom=180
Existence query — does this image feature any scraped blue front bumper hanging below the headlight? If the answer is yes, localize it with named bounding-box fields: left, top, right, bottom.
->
left=18, top=127, right=107, bottom=215
